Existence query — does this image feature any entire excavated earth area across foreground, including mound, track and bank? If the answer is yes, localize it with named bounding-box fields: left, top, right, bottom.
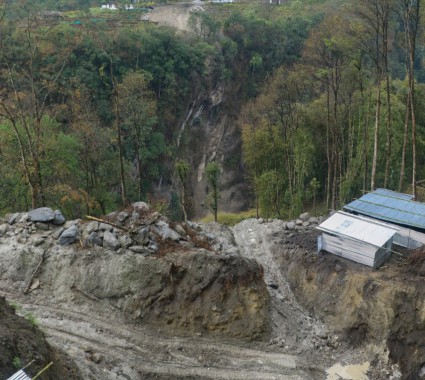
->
left=0, top=206, right=425, bottom=380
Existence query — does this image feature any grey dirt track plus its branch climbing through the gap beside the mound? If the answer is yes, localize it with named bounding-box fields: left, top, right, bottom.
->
left=0, top=219, right=332, bottom=380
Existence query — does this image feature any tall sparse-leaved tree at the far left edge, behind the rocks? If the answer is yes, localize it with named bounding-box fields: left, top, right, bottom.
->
left=0, top=12, right=76, bottom=208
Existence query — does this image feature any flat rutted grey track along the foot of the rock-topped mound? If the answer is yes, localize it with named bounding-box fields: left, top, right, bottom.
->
left=3, top=272, right=312, bottom=380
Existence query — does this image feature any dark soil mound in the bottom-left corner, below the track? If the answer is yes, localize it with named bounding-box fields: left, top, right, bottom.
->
left=0, top=297, right=82, bottom=380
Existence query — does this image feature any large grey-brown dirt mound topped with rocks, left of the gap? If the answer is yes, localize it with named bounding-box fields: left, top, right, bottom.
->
left=0, top=206, right=269, bottom=339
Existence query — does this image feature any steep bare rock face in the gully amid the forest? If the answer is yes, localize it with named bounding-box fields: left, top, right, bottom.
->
left=178, top=84, right=249, bottom=216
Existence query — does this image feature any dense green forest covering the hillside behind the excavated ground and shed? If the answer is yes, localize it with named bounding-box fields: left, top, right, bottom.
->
left=0, top=0, right=425, bottom=217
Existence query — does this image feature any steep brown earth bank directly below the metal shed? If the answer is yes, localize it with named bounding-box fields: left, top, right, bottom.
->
left=274, top=227, right=425, bottom=379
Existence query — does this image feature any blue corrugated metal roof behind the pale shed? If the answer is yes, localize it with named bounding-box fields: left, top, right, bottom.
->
left=344, top=189, right=425, bottom=229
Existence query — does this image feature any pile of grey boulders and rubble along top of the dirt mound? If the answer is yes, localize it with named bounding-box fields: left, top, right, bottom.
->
left=0, top=202, right=235, bottom=255
